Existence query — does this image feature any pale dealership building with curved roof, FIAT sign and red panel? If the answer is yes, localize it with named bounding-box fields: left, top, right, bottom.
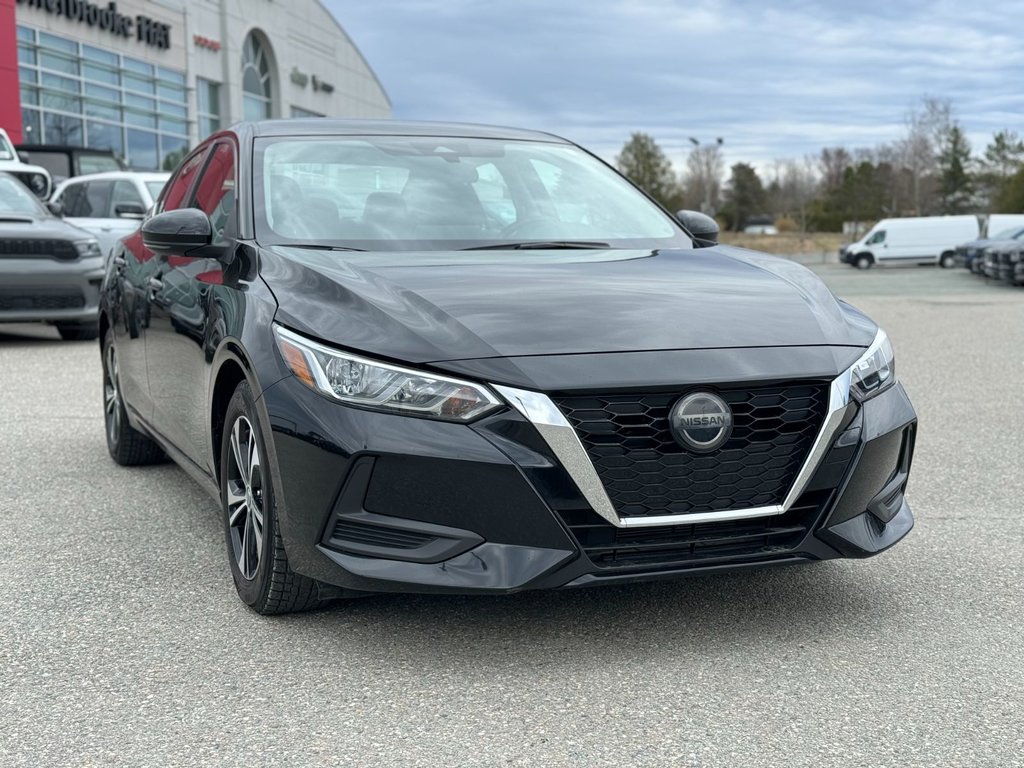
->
left=0, top=0, right=391, bottom=170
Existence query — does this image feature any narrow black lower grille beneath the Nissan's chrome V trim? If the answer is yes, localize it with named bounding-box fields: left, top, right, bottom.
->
left=559, top=490, right=831, bottom=568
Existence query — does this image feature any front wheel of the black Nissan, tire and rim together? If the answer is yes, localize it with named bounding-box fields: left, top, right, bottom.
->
left=220, top=381, right=327, bottom=614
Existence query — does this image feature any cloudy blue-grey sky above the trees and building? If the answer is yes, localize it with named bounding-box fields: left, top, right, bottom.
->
left=326, top=0, right=1024, bottom=174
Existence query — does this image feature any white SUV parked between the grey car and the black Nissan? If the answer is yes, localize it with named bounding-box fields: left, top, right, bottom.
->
left=53, top=171, right=171, bottom=256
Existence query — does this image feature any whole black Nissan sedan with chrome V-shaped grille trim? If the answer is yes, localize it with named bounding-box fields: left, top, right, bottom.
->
left=100, top=119, right=916, bottom=613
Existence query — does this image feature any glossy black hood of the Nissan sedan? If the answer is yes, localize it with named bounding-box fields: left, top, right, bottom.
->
left=260, top=246, right=873, bottom=362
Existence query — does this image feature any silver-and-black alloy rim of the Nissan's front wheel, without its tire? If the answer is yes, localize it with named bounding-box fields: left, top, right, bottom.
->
left=226, top=416, right=264, bottom=581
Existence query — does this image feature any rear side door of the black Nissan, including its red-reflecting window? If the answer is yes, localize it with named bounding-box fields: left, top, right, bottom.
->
left=113, top=153, right=204, bottom=422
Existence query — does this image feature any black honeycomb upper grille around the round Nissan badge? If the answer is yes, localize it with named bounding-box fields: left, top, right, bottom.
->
left=555, top=383, right=828, bottom=517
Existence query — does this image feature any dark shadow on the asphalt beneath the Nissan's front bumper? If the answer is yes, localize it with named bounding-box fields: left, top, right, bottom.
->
left=270, top=562, right=899, bottom=669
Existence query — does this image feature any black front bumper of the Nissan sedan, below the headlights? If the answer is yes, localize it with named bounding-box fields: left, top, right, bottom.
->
left=262, top=370, right=916, bottom=594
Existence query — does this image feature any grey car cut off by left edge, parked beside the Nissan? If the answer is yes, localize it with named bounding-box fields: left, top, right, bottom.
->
left=0, top=173, right=103, bottom=340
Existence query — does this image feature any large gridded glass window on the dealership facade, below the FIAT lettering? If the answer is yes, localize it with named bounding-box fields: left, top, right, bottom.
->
left=17, top=26, right=188, bottom=170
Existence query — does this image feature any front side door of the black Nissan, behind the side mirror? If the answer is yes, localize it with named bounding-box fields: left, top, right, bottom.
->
left=146, top=139, right=237, bottom=469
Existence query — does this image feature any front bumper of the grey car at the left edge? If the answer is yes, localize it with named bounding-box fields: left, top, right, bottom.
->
left=0, top=257, right=103, bottom=323
